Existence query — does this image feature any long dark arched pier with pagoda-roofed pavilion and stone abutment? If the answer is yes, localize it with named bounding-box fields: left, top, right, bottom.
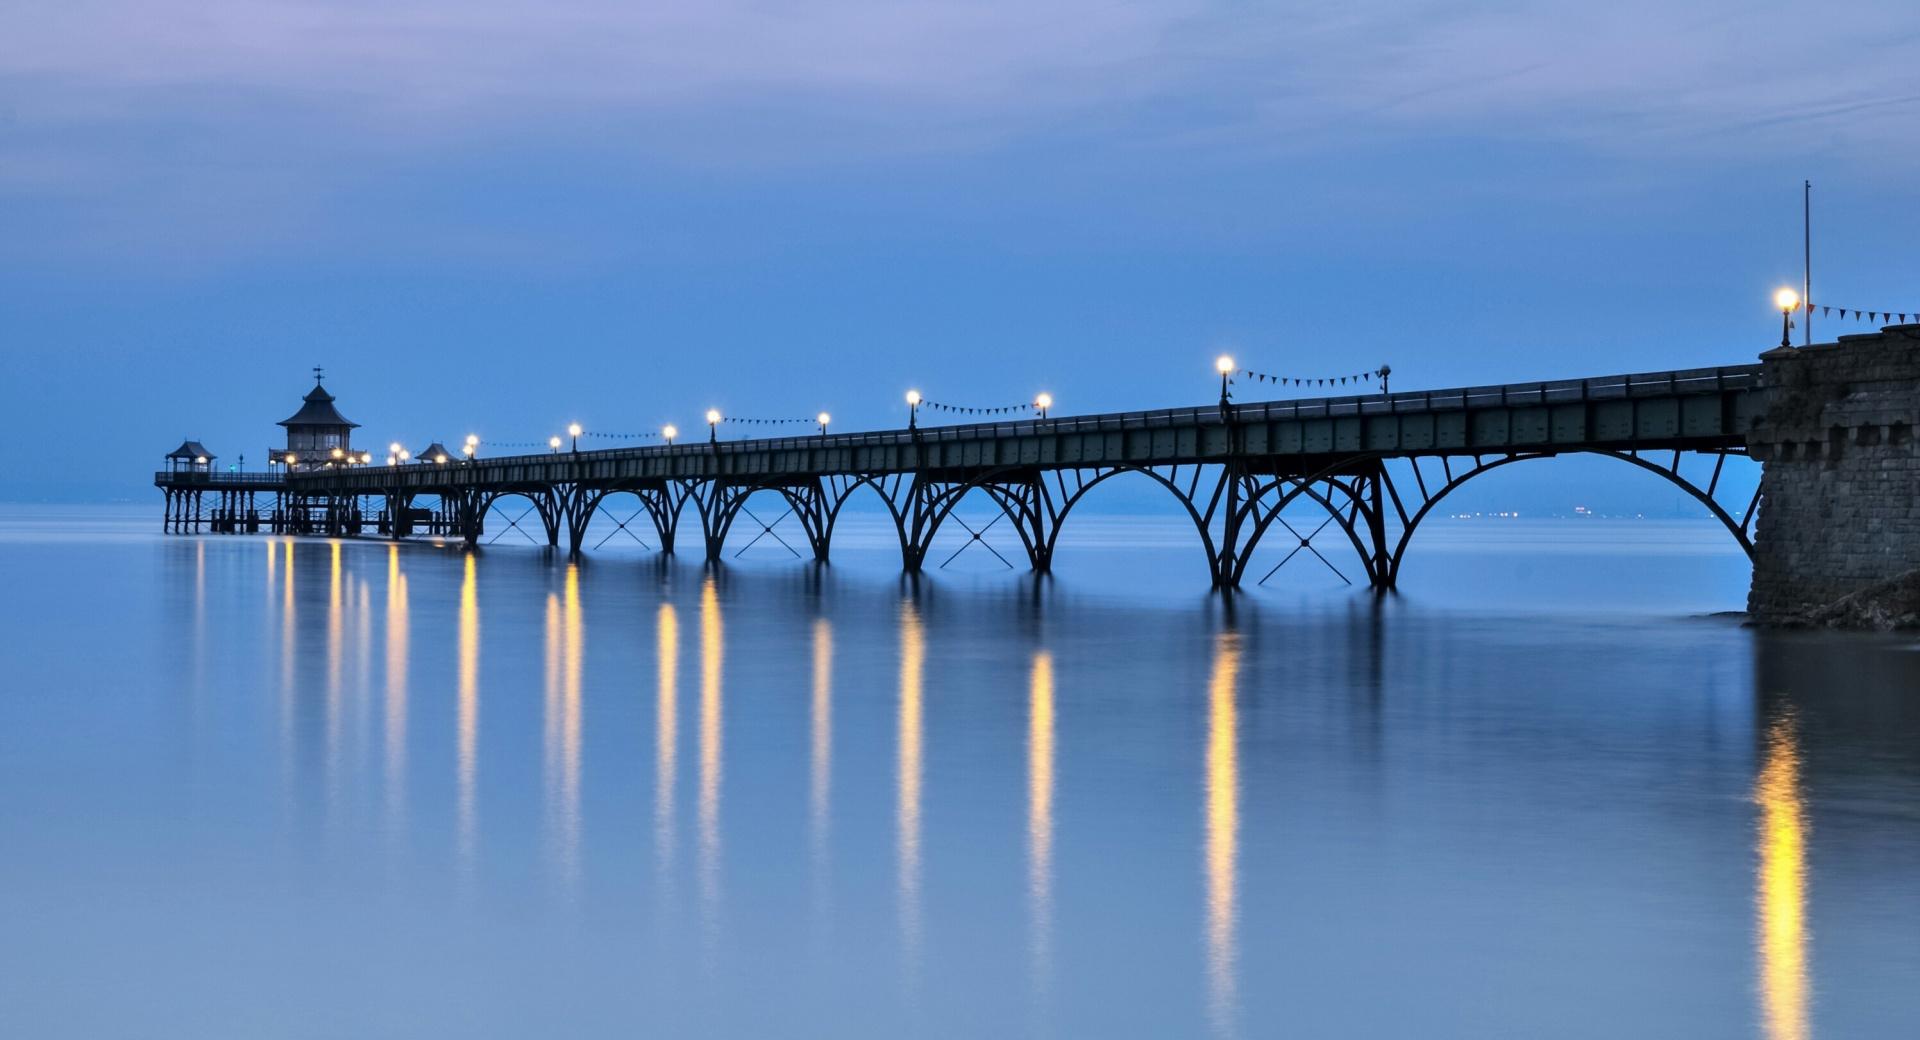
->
left=154, top=326, right=1920, bottom=612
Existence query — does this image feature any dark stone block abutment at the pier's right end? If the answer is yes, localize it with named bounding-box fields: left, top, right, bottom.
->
left=1747, top=324, right=1920, bottom=624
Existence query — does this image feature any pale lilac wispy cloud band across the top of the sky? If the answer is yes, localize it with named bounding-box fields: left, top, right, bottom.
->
left=0, top=0, right=1920, bottom=262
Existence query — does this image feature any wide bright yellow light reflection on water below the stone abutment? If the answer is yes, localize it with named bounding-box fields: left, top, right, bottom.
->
left=1753, top=718, right=1812, bottom=1040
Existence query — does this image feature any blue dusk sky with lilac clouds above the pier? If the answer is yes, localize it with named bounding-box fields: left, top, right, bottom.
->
left=0, top=0, right=1920, bottom=508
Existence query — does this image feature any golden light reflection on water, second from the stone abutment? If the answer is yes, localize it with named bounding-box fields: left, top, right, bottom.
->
left=1206, top=631, right=1240, bottom=1032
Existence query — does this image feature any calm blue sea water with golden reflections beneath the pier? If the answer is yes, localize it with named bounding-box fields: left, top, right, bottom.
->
left=0, top=503, right=1920, bottom=1040
